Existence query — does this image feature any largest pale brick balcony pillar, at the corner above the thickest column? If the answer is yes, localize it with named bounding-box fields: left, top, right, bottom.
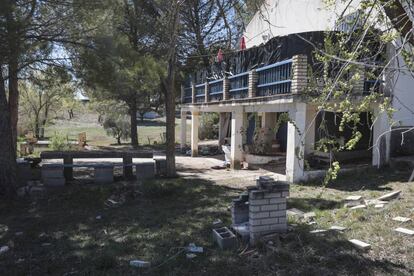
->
left=291, top=55, right=308, bottom=94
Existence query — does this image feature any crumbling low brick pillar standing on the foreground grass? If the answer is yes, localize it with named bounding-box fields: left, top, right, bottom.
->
left=249, top=177, right=289, bottom=244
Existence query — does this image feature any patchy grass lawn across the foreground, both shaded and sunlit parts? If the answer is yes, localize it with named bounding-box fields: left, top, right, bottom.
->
left=0, top=171, right=414, bottom=275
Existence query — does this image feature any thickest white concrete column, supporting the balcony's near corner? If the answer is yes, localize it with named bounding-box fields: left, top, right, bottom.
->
left=286, top=103, right=306, bottom=183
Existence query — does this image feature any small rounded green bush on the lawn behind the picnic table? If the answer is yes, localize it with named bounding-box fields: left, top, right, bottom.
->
left=103, top=114, right=131, bottom=145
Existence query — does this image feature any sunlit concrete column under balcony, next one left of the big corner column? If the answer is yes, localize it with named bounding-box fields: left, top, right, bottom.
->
left=231, top=110, right=243, bottom=170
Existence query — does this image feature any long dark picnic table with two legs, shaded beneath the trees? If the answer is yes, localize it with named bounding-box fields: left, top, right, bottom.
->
left=40, top=151, right=154, bottom=180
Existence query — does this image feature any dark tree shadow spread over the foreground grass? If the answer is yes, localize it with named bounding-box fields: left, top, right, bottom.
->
left=0, top=174, right=405, bottom=275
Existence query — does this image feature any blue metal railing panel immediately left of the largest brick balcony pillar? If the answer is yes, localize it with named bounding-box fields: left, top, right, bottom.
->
left=256, top=59, right=292, bottom=97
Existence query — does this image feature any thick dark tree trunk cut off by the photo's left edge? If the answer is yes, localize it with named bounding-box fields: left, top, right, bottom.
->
left=0, top=68, right=17, bottom=198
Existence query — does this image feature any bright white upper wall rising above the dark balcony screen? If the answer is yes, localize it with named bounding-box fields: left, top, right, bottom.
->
left=244, top=0, right=360, bottom=48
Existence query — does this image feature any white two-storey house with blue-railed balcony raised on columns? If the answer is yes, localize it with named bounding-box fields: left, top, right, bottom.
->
left=181, top=0, right=414, bottom=182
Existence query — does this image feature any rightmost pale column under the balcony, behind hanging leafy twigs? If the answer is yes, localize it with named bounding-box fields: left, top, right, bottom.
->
left=372, top=107, right=391, bottom=168
